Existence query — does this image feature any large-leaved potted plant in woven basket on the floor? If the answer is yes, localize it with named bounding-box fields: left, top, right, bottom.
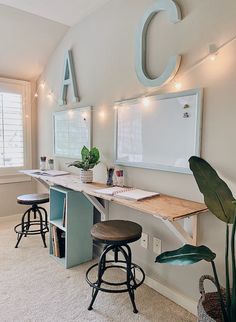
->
left=156, top=157, right=236, bottom=322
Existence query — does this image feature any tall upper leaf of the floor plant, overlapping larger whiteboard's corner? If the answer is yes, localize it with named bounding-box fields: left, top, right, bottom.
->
left=189, top=156, right=235, bottom=224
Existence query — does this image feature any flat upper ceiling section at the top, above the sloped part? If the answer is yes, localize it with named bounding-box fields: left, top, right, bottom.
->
left=0, top=0, right=109, bottom=26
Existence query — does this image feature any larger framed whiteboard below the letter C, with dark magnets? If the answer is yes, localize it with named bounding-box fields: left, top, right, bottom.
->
left=115, top=89, right=202, bottom=173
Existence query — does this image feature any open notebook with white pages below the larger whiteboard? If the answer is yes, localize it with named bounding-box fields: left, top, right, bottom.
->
left=94, top=187, right=159, bottom=201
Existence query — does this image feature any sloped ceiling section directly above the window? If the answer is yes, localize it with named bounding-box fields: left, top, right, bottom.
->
left=0, top=5, right=69, bottom=80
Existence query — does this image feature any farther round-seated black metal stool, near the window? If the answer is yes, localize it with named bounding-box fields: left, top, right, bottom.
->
left=14, top=193, right=49, bottom=248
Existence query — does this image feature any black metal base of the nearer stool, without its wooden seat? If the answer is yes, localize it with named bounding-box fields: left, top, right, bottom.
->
left=86, top=244, right=145, bottom=313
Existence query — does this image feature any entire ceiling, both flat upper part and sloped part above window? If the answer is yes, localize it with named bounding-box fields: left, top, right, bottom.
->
left=0, top=0, right=109, bottom=80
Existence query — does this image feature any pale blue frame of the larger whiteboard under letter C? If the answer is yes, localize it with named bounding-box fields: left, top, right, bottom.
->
left=114, top=88, right=203, bottom=174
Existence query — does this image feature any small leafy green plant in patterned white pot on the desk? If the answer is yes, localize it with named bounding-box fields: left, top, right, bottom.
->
left=69, top=146, right=100, bottom=183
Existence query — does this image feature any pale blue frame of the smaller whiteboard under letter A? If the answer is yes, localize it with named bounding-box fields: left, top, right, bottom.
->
left=52, top=106, right=93, bottom=160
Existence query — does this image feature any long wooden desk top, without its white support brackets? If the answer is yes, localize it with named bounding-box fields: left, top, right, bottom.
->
left=22, top=171, right=207, bottom=221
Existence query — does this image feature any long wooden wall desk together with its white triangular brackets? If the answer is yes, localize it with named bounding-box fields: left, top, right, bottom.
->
left=22, top=170, right=208, bottom=245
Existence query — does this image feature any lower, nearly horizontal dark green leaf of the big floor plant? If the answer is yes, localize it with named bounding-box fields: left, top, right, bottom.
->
left=156, top=244, right=216, bottom=265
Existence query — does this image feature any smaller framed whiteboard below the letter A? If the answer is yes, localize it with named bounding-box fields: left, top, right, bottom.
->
left=53, top=107, right=91, bottom=159
